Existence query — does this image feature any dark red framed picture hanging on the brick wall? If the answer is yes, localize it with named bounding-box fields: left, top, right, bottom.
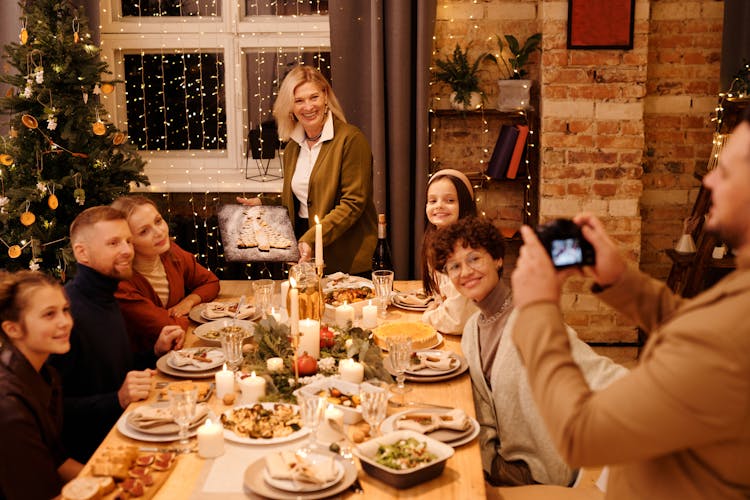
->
left=568, top=0, right=635, bottom=50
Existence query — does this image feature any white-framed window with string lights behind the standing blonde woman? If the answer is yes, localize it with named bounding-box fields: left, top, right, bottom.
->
left=100, top=0, right=330, bottom=192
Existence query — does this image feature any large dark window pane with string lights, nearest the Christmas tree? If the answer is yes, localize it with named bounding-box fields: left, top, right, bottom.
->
left=124, top=52, right=227, bottom=150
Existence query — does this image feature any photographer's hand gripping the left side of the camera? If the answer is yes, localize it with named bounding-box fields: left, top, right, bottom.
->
left=511, top=226, right=578, bottom=308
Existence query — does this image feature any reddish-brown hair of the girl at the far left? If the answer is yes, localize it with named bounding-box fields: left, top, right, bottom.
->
left=0, top=271, right=62, bottom=341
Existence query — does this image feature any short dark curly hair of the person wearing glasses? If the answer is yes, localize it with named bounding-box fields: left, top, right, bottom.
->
left=430, top=217, right=505, bottom=272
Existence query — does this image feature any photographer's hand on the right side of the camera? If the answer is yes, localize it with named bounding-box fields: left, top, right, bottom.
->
left=573, top=213, right=626, bottom=286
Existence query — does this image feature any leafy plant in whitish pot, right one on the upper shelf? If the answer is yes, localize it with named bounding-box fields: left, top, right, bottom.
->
left=495, top=33, right=542, bottom=110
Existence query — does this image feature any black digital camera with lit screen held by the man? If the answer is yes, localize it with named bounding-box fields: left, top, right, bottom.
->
left=536, top=219, right=596, bottom=269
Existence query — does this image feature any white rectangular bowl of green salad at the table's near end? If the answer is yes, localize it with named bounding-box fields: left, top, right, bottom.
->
left=354, top=430, right=453, bottom=489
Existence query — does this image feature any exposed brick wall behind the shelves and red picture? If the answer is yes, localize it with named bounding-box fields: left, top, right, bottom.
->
left=432, top=0, right=723, bottom=342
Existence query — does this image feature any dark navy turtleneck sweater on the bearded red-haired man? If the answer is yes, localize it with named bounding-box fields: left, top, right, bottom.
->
left=51, top=264, right=154, bottom=462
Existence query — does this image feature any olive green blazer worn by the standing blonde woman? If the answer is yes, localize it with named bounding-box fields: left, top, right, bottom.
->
left=281, top=118, right=378, bottom=274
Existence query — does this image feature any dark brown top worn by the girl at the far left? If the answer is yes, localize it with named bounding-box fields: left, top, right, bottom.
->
left=0, top=342, right=66, bottom=500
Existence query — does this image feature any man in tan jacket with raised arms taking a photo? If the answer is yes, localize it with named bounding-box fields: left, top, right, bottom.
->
left=512, top=104, right=750, bottom=499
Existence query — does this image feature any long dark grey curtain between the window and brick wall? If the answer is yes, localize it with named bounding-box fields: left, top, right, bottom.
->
left=329, top=0, right=436, bottom=279
